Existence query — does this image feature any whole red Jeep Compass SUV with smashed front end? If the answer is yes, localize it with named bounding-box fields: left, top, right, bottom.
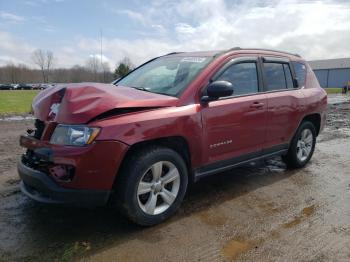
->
left=18, top=48, right=327, bottom=225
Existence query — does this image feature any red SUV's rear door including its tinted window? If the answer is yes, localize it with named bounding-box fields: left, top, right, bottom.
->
left=261, top=57, right=303, bottom=153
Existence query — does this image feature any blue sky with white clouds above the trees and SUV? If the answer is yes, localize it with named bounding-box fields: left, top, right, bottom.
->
left=0, top=0, right=350, bottom=67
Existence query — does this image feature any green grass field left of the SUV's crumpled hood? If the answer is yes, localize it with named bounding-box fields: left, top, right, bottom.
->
left=0, top=90, right=39, bottom=115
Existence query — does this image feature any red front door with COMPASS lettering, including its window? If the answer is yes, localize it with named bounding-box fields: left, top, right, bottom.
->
left=202, top=57, right=267, bottom=163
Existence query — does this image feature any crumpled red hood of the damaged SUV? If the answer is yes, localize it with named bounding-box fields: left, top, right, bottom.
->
left=33, top=83, right=178, bottom=124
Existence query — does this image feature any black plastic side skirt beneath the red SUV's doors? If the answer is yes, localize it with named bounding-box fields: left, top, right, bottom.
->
left=194, top=144, right=289, bottom=182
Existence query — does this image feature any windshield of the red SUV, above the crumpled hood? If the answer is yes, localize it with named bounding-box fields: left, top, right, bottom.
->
left=116, top=56, right=212, bottom=96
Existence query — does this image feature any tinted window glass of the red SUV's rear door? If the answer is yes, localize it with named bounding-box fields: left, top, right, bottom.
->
left=264, top=63, right=287, bottom=91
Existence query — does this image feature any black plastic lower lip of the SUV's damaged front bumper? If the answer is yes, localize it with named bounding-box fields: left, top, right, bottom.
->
left=17, top=162, right=111, bottom=206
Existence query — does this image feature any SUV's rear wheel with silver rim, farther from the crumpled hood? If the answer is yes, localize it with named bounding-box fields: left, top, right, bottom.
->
left=282, top=121, right=316, bottom=168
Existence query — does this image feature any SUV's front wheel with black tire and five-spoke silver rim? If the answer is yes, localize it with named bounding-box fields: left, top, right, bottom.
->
left=116, top=147, right=188, bottom=226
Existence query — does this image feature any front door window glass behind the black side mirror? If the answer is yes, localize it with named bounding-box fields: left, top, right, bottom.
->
left=216, top=62, right=259, bottom=95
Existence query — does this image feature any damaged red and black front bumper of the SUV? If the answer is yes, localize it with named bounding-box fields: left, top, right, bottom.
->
left=18, top=135, right=128, bottom=206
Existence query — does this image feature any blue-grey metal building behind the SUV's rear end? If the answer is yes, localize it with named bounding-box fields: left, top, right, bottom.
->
left=309, top=58, right=350, bottom=88
